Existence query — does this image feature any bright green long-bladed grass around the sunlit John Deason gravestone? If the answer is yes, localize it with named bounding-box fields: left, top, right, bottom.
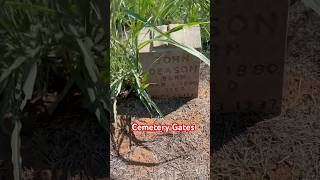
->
left=110, top=0, right=210, bottom=123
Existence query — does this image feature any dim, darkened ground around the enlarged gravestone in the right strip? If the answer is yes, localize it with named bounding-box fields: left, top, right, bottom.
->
left=211, top=2, right=320, bottom=180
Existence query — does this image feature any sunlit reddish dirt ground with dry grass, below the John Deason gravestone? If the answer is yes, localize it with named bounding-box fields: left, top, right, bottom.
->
left=110, top=64, right=210, bottom=180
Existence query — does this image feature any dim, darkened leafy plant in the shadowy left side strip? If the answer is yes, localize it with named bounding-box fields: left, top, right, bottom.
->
left=0, top=0, right=111, bottom=179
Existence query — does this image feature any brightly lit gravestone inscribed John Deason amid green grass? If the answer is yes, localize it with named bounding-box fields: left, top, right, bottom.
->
left=139, top=24, right=201, bottom=98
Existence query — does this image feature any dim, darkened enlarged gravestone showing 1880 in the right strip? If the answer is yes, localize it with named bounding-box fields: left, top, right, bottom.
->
left=211, top=0, right=288, bottom=113
